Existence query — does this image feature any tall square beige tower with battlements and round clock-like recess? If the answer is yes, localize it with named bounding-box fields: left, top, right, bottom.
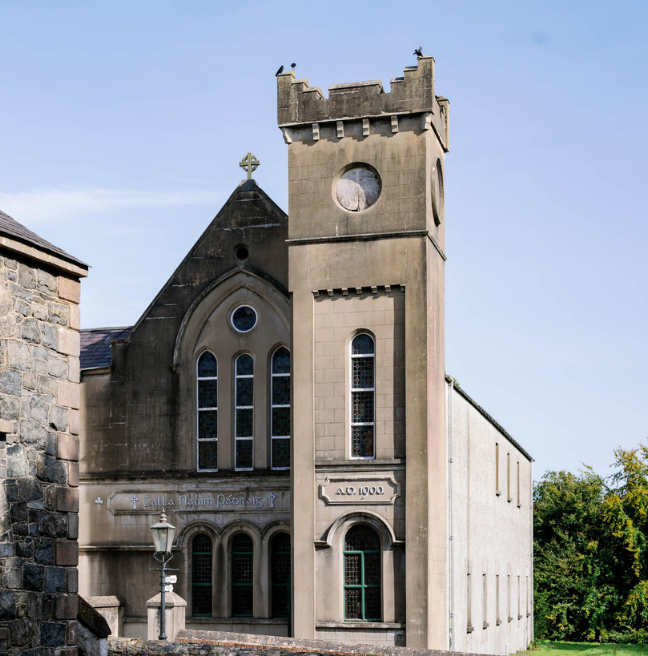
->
left=278, top=57, right=448, bottom=649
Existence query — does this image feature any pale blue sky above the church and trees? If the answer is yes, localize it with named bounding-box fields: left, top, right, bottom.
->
left=0, top=0, right=648, bottom=478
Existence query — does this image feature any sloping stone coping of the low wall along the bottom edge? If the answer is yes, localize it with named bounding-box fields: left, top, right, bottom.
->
left=176, top=626, right=484, bottom=656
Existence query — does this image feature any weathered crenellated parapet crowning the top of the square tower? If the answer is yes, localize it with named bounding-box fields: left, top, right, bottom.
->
left=277, top=57, right=450, bottom=151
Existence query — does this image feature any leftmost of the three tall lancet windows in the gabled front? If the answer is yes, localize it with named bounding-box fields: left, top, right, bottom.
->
left=197, top=351, right=218, bottom=471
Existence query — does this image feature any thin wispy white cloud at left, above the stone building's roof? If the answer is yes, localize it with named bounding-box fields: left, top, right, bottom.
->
left=0, top=189, right=223, bottom=227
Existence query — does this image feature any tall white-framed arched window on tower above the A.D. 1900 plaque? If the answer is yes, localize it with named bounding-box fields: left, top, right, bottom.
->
left=351, top=334, right=376, bottom=458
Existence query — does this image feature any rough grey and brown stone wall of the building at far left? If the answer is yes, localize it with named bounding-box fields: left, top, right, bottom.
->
left=0, top=251, right=80, bottom=655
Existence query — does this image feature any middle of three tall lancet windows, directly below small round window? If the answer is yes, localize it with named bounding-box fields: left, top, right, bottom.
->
left=234, top=353, right=254, bottom=471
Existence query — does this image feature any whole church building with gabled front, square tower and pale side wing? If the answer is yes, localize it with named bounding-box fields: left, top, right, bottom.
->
left=79, top=57, right=533, bottom=654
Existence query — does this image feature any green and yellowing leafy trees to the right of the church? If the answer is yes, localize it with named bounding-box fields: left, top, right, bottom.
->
left=534, top=446, right=648, bottom=643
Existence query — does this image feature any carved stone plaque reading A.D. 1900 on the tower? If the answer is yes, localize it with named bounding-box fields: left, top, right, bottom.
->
left=319, top=474, right=400, bottom=506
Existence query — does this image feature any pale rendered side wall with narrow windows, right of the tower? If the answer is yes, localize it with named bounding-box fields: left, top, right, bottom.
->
left=447, top=385, right=533, bottom=654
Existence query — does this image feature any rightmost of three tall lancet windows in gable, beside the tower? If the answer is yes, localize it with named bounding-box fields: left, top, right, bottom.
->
left=271, top=346, right=290, bottom=469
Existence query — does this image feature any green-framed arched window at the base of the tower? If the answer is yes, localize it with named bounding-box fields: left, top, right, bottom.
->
left=344, top=526, right=382, bottom=622
